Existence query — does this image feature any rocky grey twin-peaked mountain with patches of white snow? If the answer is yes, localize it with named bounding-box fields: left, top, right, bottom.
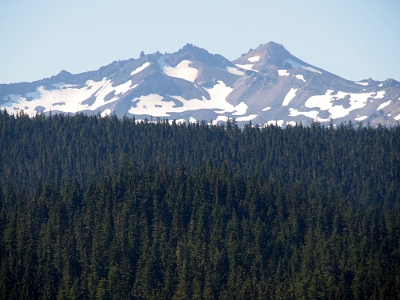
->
left=0, top=42, right=400, bottom=126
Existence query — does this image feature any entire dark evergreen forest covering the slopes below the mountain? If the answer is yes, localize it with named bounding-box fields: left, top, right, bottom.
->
left=0, top=111, right=400, bottom=299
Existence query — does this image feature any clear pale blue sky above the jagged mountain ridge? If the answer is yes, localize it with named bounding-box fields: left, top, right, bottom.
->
left=0, top=0, right=400, bottom=83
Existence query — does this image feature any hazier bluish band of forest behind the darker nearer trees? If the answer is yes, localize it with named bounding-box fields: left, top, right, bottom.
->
left=0, top=111, right=400, bottom=201
